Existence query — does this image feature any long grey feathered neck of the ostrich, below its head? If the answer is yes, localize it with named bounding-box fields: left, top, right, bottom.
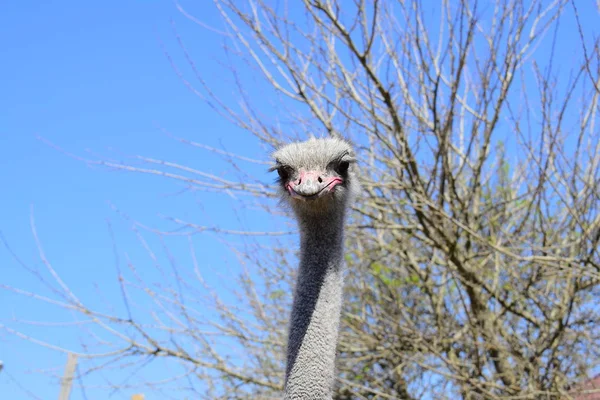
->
left=285, top=215, right=344, bottom=400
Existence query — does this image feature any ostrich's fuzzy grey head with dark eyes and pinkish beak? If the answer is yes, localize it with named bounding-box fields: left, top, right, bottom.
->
left=271, top=138, right=358, bottom=218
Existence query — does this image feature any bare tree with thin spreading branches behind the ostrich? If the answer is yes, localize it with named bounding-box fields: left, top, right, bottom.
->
left=4, top=0, right=600, bottom=400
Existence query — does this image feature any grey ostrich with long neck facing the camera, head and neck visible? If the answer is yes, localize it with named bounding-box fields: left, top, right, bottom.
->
left=272, top=138, right=358, bottom=400
